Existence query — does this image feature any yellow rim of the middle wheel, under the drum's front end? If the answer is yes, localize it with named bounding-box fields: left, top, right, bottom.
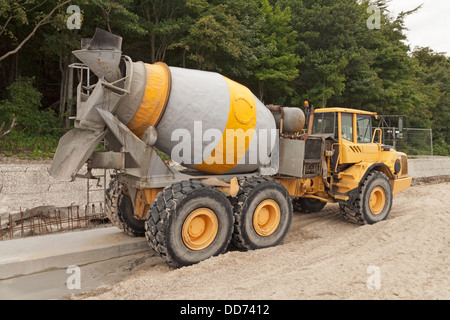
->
left=253, top=199, right=281, bottom=237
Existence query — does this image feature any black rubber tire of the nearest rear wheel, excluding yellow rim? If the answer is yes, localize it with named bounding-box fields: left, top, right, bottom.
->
left=145, top=180, right=233, bottom=268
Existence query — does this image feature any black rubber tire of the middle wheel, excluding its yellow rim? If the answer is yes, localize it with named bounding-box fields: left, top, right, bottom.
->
left=231, top=177, right=293, bottom=251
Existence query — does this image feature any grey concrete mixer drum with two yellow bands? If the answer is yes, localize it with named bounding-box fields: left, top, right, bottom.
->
left=115, top=62, right=277, bottom=174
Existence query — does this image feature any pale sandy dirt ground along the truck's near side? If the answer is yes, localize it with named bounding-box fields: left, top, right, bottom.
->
left=72, top=182, right=450, bottom=300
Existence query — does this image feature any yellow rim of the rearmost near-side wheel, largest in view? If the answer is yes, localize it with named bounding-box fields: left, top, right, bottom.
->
left=182, top=208, right=219, bottom=251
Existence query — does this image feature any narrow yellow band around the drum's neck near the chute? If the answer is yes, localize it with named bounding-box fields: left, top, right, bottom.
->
left=127, top=62, right=171, bottom=138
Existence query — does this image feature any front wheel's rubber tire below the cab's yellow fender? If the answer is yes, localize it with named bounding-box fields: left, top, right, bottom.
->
left=339, top=171, right=393, bottom=225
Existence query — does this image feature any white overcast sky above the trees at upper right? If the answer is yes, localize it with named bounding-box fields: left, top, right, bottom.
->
left=389, top=0, right=450, bottom=56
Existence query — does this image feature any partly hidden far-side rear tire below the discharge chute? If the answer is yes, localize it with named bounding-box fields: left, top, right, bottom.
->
left=105, top=179, right=145, bottom=237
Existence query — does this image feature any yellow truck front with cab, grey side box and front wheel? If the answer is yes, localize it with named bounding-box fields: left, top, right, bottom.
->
left=278, top=108, right=412, bottom=224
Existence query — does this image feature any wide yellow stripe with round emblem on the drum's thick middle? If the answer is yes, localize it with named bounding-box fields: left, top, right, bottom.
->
left=194, top=77, right=257, bottom=174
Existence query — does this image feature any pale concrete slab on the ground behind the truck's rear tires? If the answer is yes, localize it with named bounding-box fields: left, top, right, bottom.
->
left=0, top=227, right=152, bottom=280
